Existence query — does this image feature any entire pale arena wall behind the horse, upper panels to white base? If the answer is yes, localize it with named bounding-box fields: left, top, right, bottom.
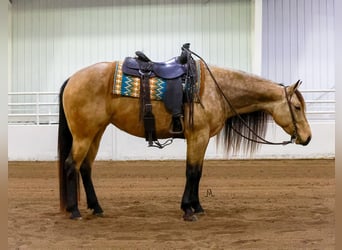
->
left=8, top=0, right=335, bottom=160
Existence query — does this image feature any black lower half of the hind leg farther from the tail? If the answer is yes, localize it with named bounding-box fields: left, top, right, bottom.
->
left=80, top=161, right=103, bottom=215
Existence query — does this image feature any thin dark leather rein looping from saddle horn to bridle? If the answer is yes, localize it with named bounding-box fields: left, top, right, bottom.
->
left=182, top=47, right=297, bottom=145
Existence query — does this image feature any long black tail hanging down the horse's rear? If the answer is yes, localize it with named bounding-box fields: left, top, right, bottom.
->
left=58, top=79, right=72, bottom=211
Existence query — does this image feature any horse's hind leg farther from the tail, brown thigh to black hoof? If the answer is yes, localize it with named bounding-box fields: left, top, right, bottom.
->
left=80, top=129, right=104, bottom=216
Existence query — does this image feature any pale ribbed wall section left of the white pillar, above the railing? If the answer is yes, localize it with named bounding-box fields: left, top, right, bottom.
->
left=11, top=0, right=252, bottom=94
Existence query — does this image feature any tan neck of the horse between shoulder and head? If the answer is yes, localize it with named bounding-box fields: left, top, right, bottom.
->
left=216, top=70, right=284, bottom=113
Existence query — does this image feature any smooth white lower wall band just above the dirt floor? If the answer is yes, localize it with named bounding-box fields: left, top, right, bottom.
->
left=8, top=122, right=335, bottom=160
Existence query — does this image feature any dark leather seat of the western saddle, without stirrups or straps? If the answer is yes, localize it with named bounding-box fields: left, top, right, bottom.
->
left=122, top=51, right=187, bottom=79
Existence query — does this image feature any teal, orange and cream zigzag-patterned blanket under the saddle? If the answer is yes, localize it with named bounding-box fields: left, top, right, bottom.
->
left=113, top=61, right=201, bottom=102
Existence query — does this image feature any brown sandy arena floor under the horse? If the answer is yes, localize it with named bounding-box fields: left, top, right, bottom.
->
left=8, top=160, right=335, bottom=249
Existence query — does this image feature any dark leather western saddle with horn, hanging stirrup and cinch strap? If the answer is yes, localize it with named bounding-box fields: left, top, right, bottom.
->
left=122, top=43, right=197, bottom=147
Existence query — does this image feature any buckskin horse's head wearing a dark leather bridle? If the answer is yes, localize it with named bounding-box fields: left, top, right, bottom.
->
left=272, top=81, right=311, bottom=146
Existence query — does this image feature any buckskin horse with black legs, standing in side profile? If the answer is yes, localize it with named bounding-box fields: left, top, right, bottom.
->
left=58, top=46, right=311, bottom=221
